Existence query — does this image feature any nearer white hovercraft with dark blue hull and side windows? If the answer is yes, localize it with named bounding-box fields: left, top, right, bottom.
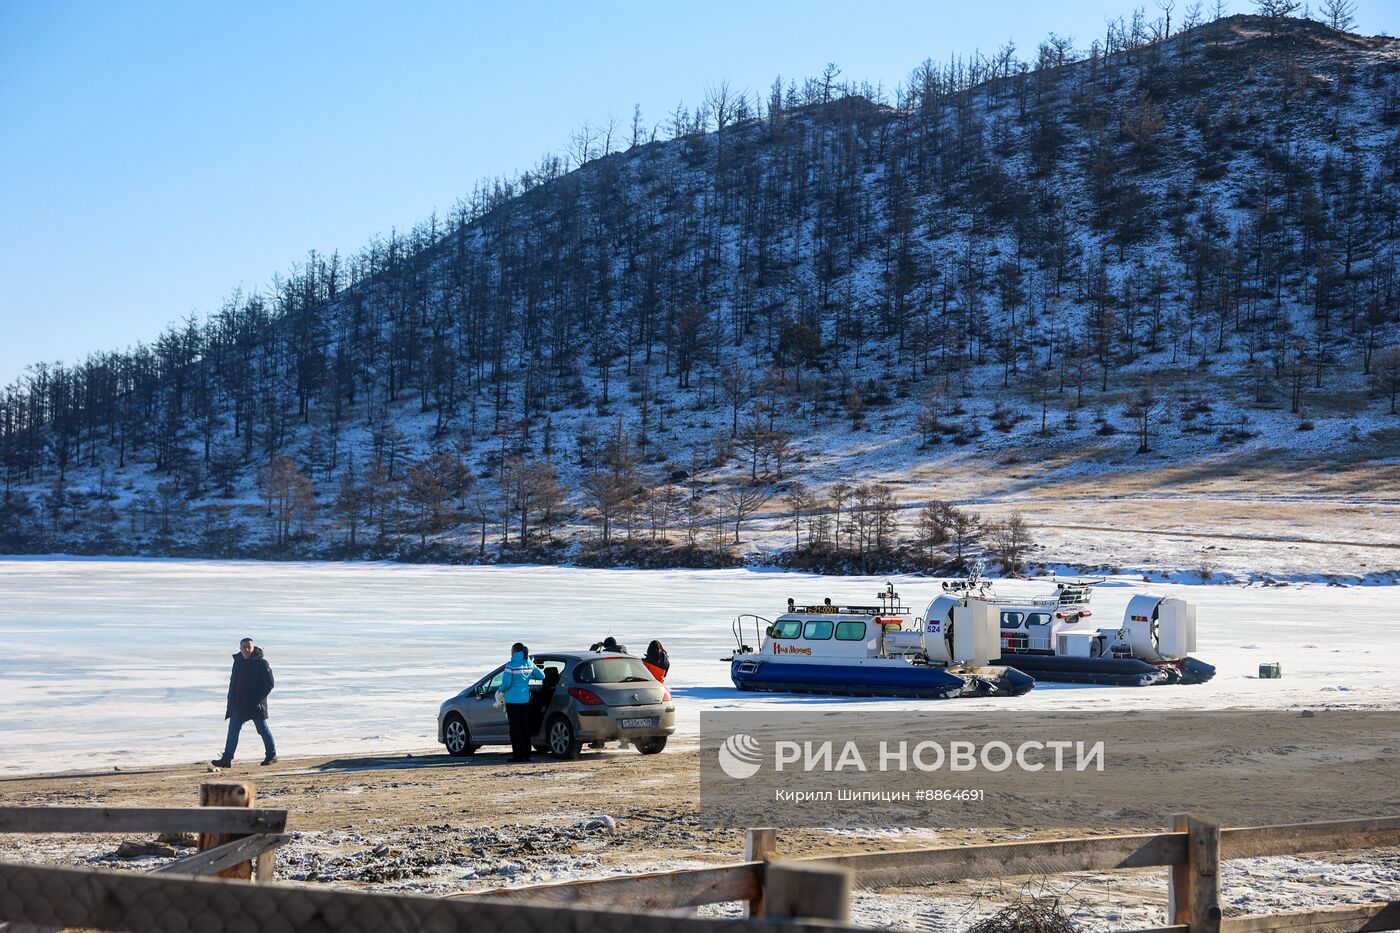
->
left=725, top=584, right=1035, bottom=699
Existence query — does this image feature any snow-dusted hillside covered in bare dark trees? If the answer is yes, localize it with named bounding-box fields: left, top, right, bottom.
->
left=0, top=17, right=1400, bottom=573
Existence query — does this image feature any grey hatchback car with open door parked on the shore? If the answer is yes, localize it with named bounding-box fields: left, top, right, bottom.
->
left=438, top=651, right=676, bottom=758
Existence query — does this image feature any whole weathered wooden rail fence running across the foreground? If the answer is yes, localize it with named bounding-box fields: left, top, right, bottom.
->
left=0, top=801, right=1400, bottom=933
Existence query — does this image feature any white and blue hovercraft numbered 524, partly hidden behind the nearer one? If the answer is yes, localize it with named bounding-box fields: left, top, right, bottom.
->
left=924, top=577, right=1215, bottom=686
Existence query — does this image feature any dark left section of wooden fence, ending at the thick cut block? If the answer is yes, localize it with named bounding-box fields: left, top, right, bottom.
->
left=0, top=782, right=858, bottom=933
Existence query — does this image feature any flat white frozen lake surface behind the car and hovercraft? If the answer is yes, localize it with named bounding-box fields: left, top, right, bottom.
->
left=0, top=559, right=1400, bottom=773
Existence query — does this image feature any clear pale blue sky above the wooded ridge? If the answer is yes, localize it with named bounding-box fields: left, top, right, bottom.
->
left=0, top=0, right=1400, bottom=384
